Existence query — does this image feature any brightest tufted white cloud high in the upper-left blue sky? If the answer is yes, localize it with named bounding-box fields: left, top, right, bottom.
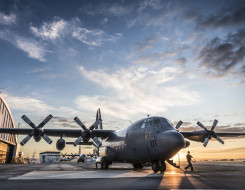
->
left=30, top=18, right=68, bottom=40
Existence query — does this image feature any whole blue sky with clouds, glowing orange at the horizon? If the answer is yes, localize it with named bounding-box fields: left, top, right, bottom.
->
left=0, top=0, right=245, bottom=159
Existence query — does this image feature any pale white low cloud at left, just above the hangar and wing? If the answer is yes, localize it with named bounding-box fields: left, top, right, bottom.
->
left=4, top=93, right=54, bottom=114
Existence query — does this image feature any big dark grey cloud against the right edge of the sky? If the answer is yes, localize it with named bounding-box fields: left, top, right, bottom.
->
left=198, top=28, right=245, bottom=77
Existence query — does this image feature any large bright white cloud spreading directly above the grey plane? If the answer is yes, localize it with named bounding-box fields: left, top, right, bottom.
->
left=78, top=67, right=200, bottom=119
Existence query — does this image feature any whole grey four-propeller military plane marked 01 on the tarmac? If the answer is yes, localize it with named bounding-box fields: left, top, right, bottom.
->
left=0, top=109, right=245, bottom=172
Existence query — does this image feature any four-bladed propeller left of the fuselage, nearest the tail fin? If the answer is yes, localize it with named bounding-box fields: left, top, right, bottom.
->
left=73, top=114, right=101, bottom=147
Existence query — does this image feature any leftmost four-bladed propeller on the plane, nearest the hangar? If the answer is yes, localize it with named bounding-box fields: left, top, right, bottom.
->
left=20, top=114, right=53, bottom=146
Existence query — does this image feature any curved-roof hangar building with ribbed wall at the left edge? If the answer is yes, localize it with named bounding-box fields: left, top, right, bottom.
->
left=0, top=93, right=17, bottom=163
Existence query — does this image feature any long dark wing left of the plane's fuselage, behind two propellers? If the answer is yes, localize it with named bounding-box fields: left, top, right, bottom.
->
left=0, top=128, right=115, bottom=139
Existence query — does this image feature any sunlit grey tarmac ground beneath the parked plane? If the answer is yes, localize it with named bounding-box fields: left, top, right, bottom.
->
left=0, top=162, right=245, bottom=190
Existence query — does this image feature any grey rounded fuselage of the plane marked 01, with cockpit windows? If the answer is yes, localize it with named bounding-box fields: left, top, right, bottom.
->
left=99, top=117, right=186, bottom=163
